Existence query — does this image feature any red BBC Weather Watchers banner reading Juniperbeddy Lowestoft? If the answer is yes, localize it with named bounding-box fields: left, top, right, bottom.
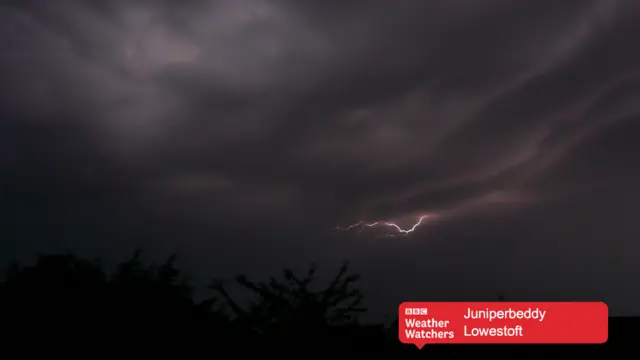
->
left=398, top=302, right=609, bottom=348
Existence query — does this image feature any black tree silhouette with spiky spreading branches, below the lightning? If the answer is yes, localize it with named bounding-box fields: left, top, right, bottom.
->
left=210, top=262, right=366, bottom=346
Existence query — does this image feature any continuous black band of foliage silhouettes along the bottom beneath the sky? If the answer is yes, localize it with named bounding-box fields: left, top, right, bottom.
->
left=0, top=251, right=639, bottom=358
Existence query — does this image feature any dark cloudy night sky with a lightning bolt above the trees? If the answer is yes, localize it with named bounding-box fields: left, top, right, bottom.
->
left=0, top=0, right=640, bottom=315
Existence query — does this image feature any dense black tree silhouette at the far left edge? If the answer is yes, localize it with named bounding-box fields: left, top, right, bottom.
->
left=0, top=251, right=226, bottom=336
